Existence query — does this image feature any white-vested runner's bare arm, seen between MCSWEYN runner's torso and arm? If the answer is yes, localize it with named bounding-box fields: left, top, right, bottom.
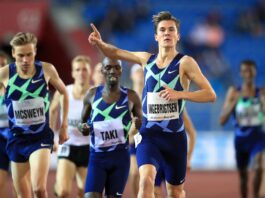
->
left=50, top=91, right=61, bottom=131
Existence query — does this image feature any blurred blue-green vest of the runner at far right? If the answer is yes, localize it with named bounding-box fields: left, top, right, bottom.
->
left=233, top=88, right=264, bottom=136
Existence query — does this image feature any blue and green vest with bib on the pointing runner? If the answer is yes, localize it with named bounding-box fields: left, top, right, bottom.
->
left=140, top=54, right=185, bottom=133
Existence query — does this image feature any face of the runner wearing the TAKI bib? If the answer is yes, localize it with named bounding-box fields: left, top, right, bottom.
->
left=102, top=60, right=122, bottom=84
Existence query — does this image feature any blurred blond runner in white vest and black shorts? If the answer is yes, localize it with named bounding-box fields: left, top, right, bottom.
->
left=50, top=55, right=91, bottom=197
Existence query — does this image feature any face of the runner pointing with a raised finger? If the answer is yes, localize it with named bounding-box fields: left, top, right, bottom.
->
left=155, top=20, right=180, bottom=47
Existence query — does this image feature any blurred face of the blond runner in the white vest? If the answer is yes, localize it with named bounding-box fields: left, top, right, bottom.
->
left=72, top=62, right=90, bottom=84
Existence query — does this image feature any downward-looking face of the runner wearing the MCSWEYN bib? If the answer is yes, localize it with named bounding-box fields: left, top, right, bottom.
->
left=12, top=43, right=36, bottom=72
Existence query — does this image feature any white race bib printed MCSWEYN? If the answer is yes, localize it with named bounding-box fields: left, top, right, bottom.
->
left=12, top=98, right=45, bottom=126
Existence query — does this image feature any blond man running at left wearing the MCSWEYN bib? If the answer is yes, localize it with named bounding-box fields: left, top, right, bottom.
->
left=0, top=32, right=68, bottom=197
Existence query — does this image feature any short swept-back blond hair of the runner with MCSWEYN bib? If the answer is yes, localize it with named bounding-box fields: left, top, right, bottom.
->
left=10, top=32, right=38, bottom=48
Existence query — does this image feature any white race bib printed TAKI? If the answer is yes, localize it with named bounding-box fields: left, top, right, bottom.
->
left=93, top=119, right=126, bottom=148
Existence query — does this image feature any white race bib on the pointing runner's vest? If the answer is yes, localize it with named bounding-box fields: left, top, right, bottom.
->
left=147, top=92, right=179, bottom=121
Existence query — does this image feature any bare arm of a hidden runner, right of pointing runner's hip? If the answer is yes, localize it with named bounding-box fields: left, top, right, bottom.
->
left=183, top=109, right=196, bottom=169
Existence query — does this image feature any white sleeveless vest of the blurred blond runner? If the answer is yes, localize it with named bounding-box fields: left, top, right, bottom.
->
left=64, top=85, right=89, bottom=146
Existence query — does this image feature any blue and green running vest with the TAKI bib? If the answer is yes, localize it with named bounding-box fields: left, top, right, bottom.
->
left=88, top=86, right=132, bottom=152
